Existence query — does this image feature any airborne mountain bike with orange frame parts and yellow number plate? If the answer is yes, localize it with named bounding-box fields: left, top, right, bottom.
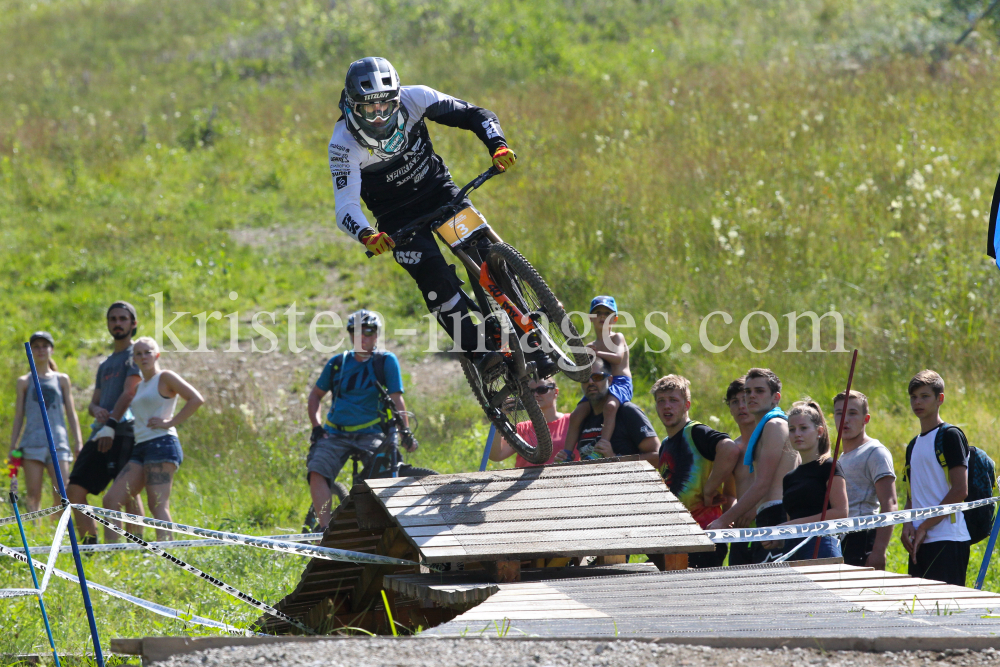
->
left=368, top=167, right=592, bottom=463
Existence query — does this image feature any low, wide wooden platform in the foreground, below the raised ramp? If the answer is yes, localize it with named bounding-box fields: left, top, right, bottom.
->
left=426, top=561, right=1000, bottom=650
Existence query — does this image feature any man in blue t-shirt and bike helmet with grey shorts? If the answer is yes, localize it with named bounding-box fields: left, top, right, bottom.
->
left=306, top=310, right=416, bottom=531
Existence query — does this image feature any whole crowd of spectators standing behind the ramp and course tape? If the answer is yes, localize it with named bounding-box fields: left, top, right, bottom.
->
left=10, top=296, right=992, bottom=585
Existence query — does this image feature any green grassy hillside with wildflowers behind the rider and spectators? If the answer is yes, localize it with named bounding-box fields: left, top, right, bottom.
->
left=0, top=0, right=1000, bottom=652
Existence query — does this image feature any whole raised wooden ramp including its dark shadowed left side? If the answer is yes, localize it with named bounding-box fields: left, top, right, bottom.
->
left=256, top=459, right=715, bottom=634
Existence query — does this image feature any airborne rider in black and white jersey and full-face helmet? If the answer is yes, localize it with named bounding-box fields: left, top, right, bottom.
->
left=329, top=58, right=516, bottom=366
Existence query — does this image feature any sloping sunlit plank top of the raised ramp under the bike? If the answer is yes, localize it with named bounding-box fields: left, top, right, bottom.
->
left=366, top=460, right=715, bottom=563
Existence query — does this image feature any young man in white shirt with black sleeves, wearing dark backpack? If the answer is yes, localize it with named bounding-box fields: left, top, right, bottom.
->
left=900, top=370, right=996, bottom=586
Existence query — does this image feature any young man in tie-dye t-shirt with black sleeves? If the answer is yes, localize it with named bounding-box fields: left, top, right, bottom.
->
left=652, top=375, right=739, bottom=568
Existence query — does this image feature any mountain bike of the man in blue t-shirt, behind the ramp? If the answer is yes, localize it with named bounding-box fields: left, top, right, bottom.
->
left=302, top=382, right=438, bottom=533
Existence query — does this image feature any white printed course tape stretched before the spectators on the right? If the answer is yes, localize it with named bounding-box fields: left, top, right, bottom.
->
left=705, top=497, right=1000, bottom=544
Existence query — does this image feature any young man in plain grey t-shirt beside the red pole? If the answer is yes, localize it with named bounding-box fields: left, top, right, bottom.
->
left=833, top=391, right=899, bottom=570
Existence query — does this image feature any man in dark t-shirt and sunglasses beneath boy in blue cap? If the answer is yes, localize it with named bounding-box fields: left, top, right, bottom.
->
left=556, top=358, right=660, bottom=466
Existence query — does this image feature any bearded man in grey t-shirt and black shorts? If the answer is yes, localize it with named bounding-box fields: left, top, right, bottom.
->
left=66, top=301, right=143, bottom=544
